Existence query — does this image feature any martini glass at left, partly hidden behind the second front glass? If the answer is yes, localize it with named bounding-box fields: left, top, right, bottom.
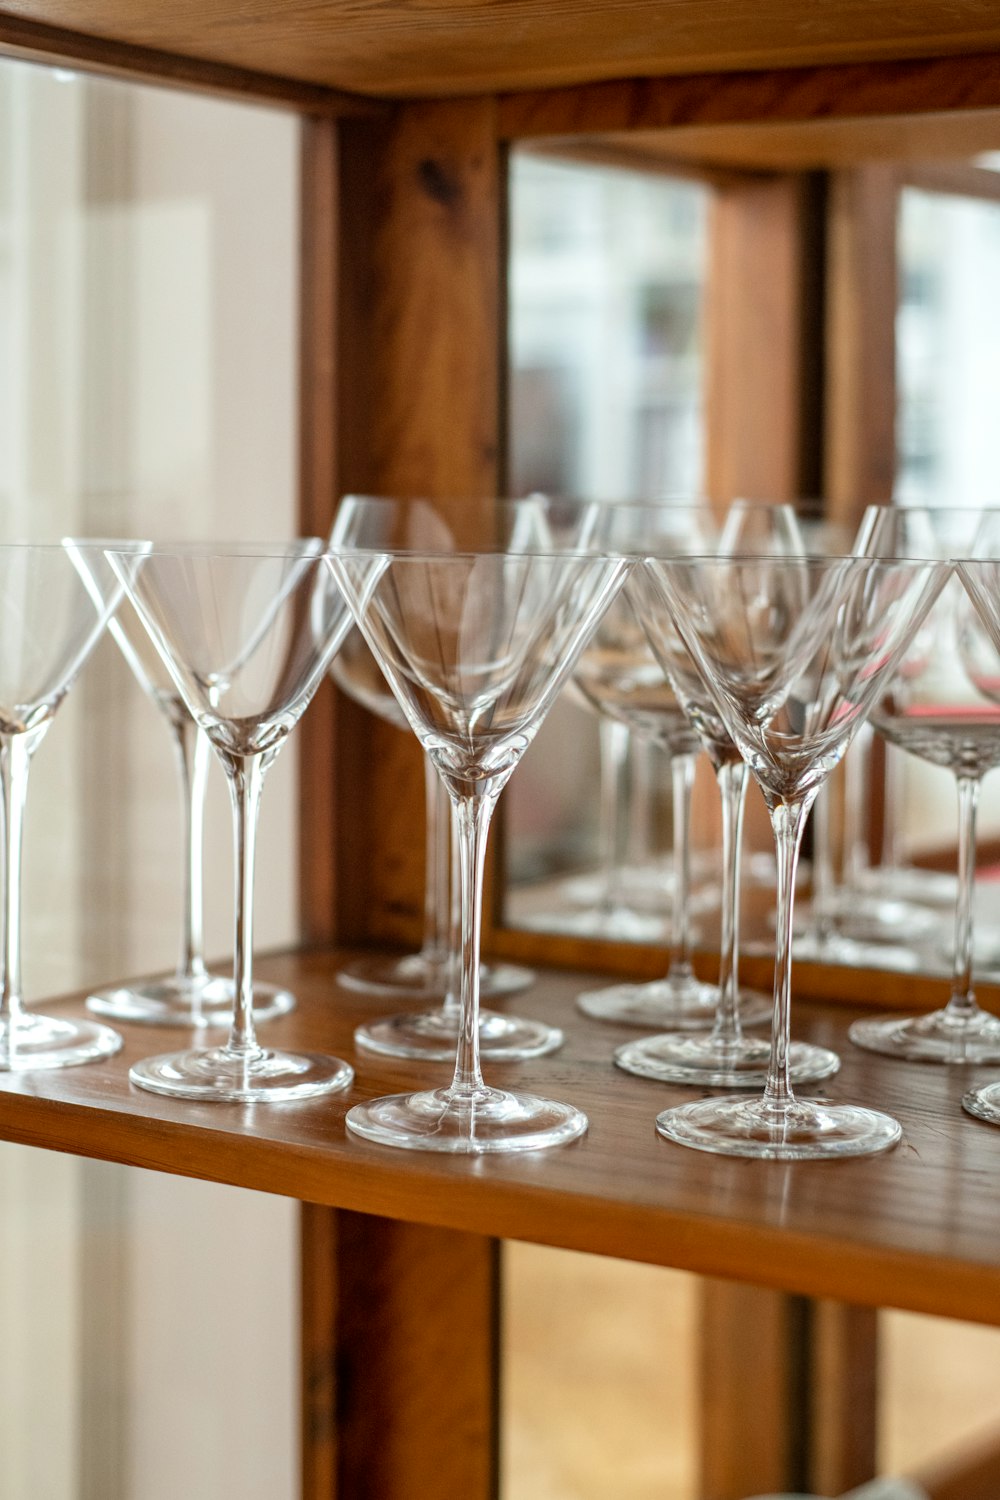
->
left=87, top=585, right=295, bottom=1026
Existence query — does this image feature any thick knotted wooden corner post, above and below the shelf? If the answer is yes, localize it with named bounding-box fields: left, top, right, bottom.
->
left=300, top=99, right=502, bottom=1500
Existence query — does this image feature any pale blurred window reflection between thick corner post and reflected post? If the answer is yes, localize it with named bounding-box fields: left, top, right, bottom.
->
left=504, top=150, right=709, bottom=927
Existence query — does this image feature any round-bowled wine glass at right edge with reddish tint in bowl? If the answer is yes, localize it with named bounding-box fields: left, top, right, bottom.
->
left=850, top=507, right=1000, bottom=1064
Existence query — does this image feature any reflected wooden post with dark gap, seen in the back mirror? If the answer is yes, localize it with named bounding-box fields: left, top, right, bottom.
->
left=700, top=174, right=885, bottom=1500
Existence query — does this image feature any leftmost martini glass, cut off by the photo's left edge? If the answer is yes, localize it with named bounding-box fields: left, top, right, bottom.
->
left=0, top=543, right=121, bottom=1073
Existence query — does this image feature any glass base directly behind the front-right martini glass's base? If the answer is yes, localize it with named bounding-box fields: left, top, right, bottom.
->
left=615, top=1032, right=840, bottom=1089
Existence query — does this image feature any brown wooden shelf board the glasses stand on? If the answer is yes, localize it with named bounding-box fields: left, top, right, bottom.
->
left=0, top=951, right=1000, bottom=1323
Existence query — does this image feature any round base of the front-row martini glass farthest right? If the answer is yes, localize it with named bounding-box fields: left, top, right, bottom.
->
left=657, top=1098, right=903, bottom=1161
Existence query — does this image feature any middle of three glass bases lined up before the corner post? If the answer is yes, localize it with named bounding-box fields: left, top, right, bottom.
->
left=354, top=1007, right=564, bottom=1062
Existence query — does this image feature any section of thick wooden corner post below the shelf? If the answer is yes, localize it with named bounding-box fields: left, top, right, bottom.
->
left=301, top=1205, right=499, bottom=1500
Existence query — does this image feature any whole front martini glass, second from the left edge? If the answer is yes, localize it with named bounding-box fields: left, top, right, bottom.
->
left=108, top=540, right=354, bottom=1103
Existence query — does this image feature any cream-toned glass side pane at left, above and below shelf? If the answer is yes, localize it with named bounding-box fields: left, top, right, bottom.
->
left=0, top=62, right=298, bottom=1500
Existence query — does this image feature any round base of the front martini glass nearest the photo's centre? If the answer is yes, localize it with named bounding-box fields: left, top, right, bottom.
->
left=346, top=1088, right=588, bottom=1155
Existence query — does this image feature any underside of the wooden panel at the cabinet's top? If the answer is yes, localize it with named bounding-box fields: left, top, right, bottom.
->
left=0, top=0, right=1000, bottom=98
